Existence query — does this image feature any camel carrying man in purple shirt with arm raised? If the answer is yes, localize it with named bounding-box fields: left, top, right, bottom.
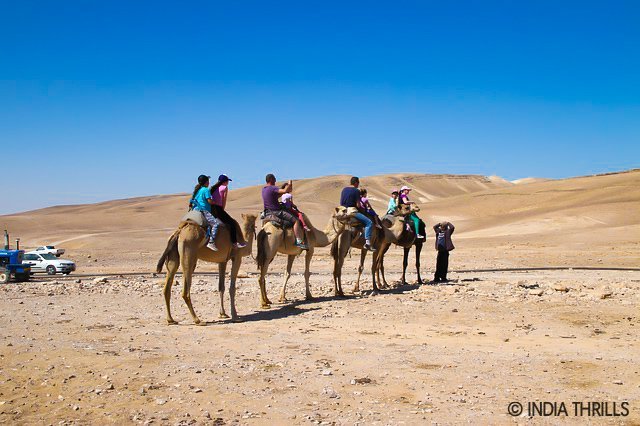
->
left=256, top=207, right=348, bottom=309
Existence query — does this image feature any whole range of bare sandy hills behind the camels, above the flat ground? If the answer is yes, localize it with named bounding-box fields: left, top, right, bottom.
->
left=0, top=170, right=640, bottom=264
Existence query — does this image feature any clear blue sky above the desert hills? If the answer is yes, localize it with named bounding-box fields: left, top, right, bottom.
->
left=0, top=0, right=640, bottom=214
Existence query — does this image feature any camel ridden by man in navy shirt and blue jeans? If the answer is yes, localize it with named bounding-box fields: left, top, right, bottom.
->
left=331, top=204, right=420, bottom=296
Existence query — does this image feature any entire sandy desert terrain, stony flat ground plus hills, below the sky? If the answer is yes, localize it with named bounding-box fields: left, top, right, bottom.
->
left=0, top=171, right=640, bottom=424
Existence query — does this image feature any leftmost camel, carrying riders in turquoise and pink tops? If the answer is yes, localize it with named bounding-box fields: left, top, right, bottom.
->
left=156, top=214, right=257, bottom=325
